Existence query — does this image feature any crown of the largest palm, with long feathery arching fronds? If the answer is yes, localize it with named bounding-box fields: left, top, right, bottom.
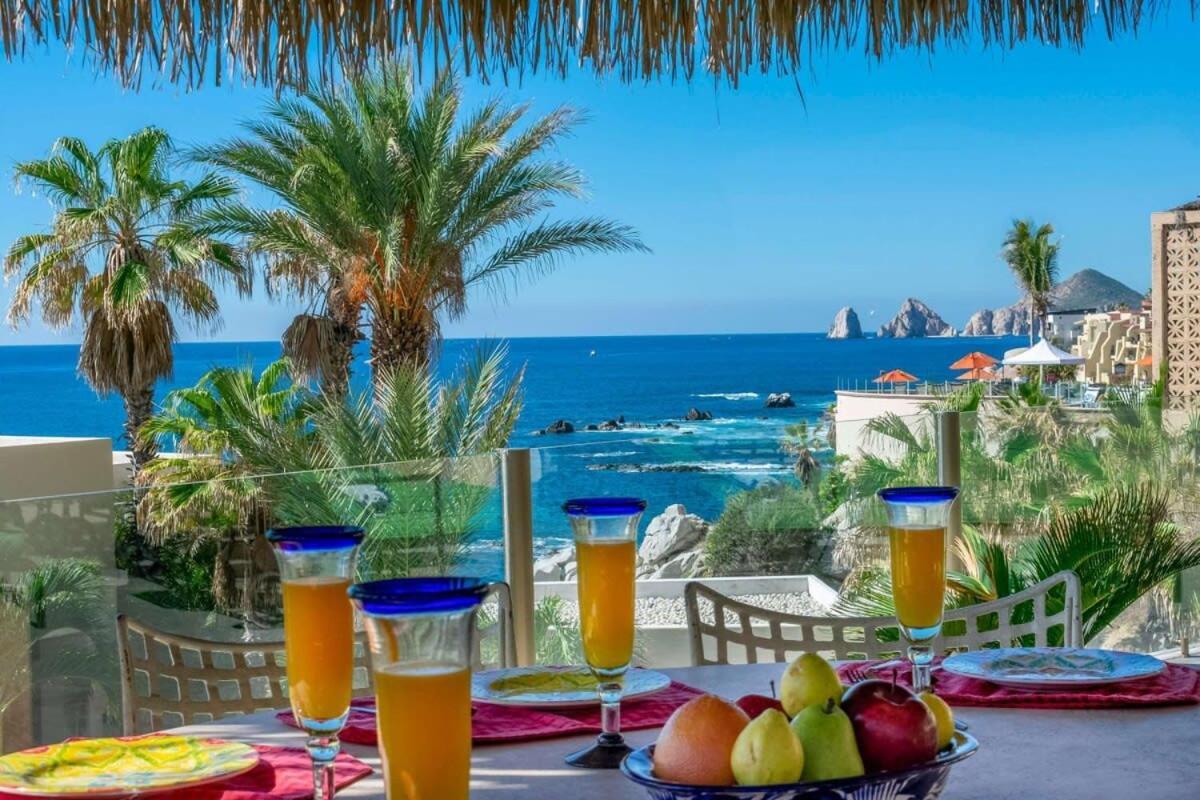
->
left=193, top=67, right=644, bottom=397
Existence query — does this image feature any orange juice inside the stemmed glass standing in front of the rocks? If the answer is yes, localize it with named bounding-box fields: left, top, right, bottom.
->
left=575, top=540, right=637, bottom=669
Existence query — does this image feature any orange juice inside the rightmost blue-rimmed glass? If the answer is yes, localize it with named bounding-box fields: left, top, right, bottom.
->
left=888, top=528, right=946, bottom=628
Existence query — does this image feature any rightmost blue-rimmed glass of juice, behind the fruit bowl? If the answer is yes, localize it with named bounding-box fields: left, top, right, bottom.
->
left=878, top=486, right=959, bottom=692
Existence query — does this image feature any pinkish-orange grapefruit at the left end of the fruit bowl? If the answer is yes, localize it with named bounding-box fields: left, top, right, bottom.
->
left=654, top=694, right=750, bottom=786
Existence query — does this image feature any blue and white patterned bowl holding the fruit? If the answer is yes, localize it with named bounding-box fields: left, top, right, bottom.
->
left=620, top=732, right=979, bottom=800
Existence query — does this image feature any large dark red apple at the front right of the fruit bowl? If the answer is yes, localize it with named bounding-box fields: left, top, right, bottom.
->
left=841, top=680, right=937, bottom=772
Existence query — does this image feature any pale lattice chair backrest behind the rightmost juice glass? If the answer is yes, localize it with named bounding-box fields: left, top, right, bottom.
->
left=684, top=571, right=1082, bottom=666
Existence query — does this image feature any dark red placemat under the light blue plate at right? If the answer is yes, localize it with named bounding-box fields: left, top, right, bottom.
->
left=838, top=660, right=1200, bottom=709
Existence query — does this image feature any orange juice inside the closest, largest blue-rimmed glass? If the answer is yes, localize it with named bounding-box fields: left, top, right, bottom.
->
left=376, top=663, right=470, bottom=800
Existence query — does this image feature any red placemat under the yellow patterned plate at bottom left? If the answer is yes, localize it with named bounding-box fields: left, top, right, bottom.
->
left=0, top=745, right=372, bottom=800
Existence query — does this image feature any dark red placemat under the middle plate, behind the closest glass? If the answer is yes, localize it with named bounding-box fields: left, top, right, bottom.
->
left=277, top=682, right=703, bottom=746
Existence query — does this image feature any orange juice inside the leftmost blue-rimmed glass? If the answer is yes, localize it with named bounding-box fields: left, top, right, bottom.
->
left=283, top=577, right=354, bottom=720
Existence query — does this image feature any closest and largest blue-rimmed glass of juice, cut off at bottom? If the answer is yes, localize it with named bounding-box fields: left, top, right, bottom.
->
left=350, top=577, right=487, bottom=800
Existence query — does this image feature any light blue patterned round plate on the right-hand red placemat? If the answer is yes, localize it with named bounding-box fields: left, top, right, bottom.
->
left=942, top=648, right=1166, bottom=690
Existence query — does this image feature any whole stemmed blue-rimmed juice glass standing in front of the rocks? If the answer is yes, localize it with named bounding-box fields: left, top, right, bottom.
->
left=563, top=498, right=646, bottom=769
